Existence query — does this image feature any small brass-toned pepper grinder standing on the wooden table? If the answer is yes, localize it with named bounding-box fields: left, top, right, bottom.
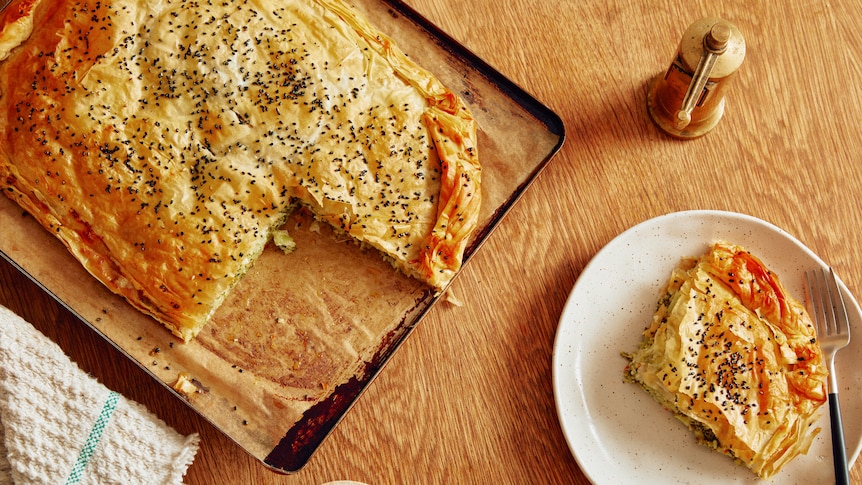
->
left=647, top=18, right=745, bottom=139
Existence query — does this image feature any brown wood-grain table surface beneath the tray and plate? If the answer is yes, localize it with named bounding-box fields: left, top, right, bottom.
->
left=0, top=0, right=862, bottom=484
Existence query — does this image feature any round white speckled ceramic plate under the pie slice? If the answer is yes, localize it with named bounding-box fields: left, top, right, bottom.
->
left=553, top=211, right=862, bottom=485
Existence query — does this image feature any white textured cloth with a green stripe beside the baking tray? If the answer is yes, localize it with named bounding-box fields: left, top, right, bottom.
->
left=0, top=306, right=198, bottom=485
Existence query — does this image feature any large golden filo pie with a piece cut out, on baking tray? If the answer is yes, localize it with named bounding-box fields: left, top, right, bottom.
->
left=0, top=0, right=481, bottom=340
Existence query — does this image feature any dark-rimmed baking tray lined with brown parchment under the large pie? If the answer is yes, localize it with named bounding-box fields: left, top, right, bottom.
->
left=0, top=0, right=565, bottom=473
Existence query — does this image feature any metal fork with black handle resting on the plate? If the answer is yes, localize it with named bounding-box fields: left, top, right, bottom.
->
left=805, top=268, right=850, bottom=485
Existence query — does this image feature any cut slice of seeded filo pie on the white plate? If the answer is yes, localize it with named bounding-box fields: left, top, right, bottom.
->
left=625, top=242, right=827, bottom=478
